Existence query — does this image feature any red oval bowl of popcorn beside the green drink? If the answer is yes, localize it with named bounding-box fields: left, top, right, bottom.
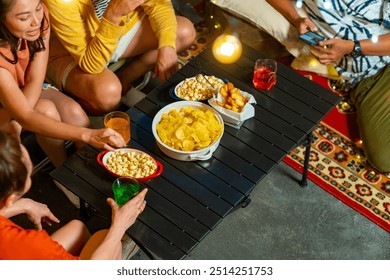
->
left=97, top=148, right=164, bottom=182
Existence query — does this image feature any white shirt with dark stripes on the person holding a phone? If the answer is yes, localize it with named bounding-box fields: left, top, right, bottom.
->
left=304, top=0, right=390, bottom=85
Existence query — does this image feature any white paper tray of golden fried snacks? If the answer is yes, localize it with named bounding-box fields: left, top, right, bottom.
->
left=208, top=82, right=256, bottom=128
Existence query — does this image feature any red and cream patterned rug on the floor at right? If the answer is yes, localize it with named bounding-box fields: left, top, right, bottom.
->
left=284, top=71, right=390, bottom=232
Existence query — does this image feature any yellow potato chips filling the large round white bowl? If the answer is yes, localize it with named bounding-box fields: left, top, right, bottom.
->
left=156, top=107, right=223, bottom=151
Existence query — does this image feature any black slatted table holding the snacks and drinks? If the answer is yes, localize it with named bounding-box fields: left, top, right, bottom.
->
left=51, top=45, right=340, bottom=259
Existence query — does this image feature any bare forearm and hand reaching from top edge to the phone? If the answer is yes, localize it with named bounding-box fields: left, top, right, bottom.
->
left=267, top=0, right=318, bottom=34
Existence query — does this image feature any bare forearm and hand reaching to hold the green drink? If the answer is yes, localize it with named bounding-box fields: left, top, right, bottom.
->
left=87, top=189, right=147, bottom=260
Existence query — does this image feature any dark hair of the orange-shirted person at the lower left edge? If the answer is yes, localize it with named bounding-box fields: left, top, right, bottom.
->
left=0, top=131, right=27, bottom=201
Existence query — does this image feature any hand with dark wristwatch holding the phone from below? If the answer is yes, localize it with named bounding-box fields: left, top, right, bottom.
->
left=311, top=39, right=354, bottom=65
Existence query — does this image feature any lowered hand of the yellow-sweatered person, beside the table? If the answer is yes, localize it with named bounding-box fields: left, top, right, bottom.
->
left=154, top=47, right=178, bottom=82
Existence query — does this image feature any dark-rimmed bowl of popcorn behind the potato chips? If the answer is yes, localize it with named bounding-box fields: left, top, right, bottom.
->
left=171, top=74, right=225, bottom=101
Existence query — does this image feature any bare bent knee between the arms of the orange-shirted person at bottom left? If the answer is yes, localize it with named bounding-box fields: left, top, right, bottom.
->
left=51, top=220, right=90, bottom=256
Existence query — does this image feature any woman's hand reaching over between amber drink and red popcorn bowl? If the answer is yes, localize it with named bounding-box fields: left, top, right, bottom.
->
left=82, top=128, right=126, bottom=151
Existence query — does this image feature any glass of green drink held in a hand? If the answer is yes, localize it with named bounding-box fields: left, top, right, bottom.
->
left=112, top=177, right=139, bottom=206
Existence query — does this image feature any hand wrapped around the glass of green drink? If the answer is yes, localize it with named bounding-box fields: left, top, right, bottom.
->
left=107, top=189, right=148, bottom=233
